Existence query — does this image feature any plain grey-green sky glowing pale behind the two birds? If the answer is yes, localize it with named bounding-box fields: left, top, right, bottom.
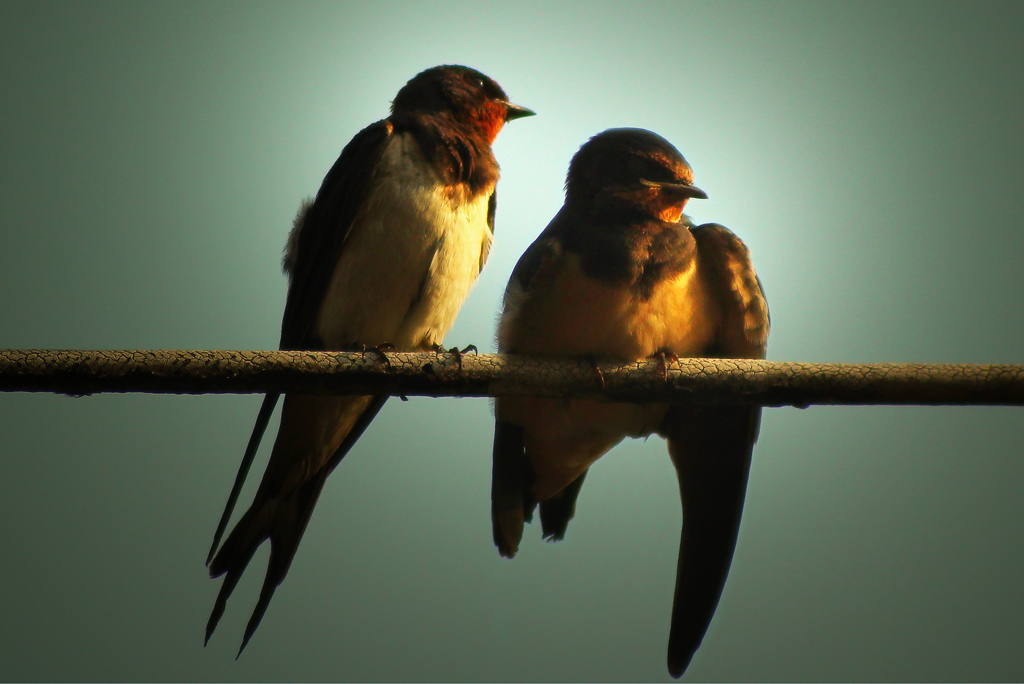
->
left=0, top=0, right=1024, bottom=681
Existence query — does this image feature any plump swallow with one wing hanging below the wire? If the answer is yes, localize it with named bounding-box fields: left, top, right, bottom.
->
left=492, top=128, right=770, bottom=678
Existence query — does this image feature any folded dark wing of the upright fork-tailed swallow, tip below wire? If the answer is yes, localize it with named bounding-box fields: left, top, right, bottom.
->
left=206, top=119, right=392, bottom=565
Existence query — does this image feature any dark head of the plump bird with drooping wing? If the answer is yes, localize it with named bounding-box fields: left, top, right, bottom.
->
left=565, top=128, right=708, bottom=223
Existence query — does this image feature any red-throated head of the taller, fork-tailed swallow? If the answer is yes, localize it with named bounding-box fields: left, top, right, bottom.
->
left=391, top=66, right=534, bottom=142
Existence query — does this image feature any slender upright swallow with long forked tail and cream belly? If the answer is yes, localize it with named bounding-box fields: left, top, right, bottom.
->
left=206, top=66, right=534, bottom=655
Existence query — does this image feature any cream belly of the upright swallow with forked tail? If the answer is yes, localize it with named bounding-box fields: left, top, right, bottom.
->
left=316, top=134, right=493, bottom=349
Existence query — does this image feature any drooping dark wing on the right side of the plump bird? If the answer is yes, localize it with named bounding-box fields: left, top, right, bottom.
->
left=658, top=224, right=769, bottom=677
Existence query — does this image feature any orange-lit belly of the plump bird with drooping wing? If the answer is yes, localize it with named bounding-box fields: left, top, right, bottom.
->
left=496, top=250, right=716, bottom=500
